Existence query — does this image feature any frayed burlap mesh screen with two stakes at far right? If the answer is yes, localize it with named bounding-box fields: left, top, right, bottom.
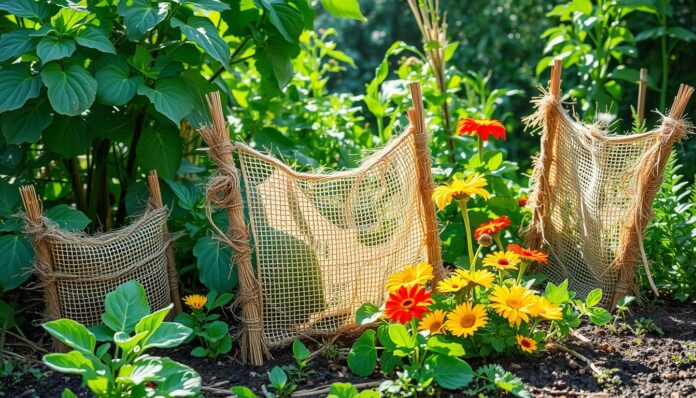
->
left=526, top=62, right=693, bottom=307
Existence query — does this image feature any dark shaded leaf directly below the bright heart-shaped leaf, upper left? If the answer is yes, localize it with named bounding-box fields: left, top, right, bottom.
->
left=43, top=115, right=90, bottom=158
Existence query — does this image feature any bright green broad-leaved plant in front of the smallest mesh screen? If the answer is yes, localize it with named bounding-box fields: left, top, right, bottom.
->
left=42, top=281, right=201, bottom=397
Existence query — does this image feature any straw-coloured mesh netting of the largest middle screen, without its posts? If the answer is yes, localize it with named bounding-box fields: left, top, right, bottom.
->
left=237, top=130, right=426, bottom=345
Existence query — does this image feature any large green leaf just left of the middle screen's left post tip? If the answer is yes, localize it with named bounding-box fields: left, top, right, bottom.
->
left=138, top=78, right=195, bottom=127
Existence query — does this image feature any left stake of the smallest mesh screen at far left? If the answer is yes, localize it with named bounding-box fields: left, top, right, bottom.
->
left=19, top=185, right=68, bottom=352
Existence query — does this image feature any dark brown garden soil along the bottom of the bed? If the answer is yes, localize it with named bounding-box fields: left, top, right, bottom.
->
left=0, top=290, right=696, bottom=397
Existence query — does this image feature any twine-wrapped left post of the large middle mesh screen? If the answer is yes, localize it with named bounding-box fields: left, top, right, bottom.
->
left=198, top=92, right=271, bottom=366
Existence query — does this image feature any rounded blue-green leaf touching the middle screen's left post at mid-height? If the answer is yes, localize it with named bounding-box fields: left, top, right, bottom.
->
left=193, top=236, right=238, bottom=292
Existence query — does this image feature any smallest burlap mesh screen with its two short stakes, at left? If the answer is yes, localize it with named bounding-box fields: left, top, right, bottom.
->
left=21, top=172, right=181, bottom=349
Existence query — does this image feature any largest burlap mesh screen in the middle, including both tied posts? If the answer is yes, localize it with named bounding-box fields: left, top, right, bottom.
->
left=201, top=85, right=442, bottom=364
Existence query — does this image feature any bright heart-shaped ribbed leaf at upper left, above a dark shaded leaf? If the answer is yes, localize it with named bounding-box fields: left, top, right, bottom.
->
left=41, top=63, right=97, bottom=116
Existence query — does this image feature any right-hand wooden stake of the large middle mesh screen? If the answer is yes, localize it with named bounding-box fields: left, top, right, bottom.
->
left=408, top=82, right=444, bottom=283
